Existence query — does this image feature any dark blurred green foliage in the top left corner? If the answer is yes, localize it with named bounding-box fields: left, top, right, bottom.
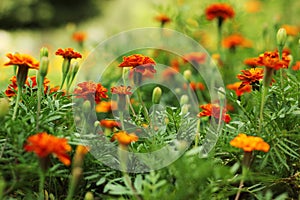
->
left=0, top=0, right=108, bottom=29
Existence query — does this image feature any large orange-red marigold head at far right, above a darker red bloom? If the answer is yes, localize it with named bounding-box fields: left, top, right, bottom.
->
left=257, top=51, right=291, bottom=70
